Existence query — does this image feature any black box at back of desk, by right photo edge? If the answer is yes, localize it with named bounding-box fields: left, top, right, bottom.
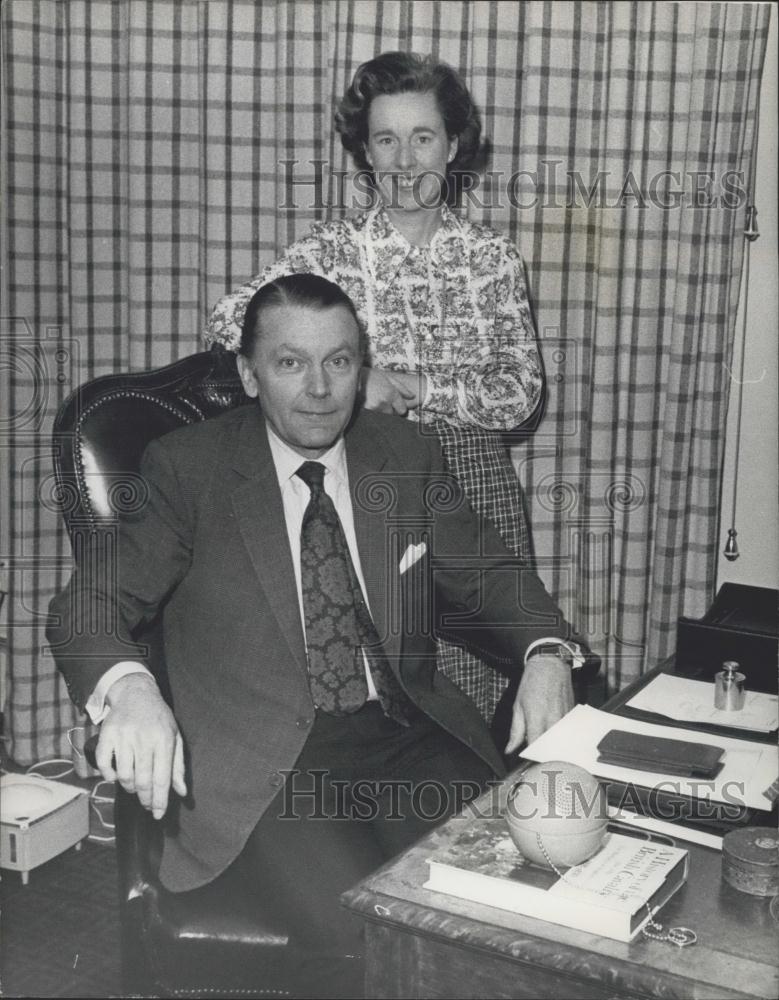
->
left=676, top=583, right=779, bottom=694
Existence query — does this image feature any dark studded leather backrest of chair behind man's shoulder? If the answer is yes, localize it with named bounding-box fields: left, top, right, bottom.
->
left=53, top=347, right=248, bottom=537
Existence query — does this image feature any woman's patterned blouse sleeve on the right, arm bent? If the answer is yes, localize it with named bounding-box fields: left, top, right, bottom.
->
left=422, top=239, right=543, bottom=431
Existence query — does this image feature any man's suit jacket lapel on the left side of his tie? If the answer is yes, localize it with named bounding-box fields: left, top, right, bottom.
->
left=232, top=406, right=308, bottom=678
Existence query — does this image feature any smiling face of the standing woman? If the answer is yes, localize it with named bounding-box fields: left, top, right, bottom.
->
left=366, top=92, right=457, bottom=213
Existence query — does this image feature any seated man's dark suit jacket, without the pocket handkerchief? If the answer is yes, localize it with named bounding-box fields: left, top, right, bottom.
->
left=49, top=405, right=567, bottom=890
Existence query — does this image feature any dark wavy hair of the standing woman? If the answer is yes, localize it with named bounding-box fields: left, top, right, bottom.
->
left=335, top=52, right=481, bottom=173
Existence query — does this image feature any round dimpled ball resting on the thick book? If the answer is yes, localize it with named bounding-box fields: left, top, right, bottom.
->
left=506, top=760, right=608, bottom=868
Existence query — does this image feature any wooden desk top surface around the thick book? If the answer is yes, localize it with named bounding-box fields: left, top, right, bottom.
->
left=343, top=778, right=779, bottom=1000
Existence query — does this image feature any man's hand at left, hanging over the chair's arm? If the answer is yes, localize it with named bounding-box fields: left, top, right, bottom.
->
left=95, top=673, right=187, bottom=819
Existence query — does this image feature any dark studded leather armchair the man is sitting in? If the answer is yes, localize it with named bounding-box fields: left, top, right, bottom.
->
left=54, top=348, right=299, bottom=998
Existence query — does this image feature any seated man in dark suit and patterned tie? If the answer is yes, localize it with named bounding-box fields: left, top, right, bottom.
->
left=49, top=274, right=575, bottom=994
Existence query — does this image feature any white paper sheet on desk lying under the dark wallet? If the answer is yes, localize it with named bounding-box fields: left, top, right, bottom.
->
left=522, top=705, right=779, bottom=826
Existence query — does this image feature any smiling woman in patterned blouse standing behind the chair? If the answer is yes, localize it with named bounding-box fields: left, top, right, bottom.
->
left=207, top=52, right=542, bottom=722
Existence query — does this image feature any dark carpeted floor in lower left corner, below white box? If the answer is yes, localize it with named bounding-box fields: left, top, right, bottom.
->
left=0, top=842, right=121, bottom=997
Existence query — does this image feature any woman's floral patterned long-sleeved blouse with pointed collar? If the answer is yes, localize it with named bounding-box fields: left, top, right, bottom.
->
left=206, top=207, right=542, bottom=430
